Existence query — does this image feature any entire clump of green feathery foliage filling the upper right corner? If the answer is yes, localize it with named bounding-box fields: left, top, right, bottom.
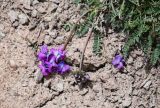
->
left=68, top=0, right=160, bottom=66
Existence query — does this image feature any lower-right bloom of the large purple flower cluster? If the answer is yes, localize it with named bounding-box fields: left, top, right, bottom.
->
left=57, top=61, right=70, bottom=74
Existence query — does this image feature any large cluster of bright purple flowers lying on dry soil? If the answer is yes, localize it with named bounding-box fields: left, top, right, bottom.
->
left=38, top=45, right=70, bottom=76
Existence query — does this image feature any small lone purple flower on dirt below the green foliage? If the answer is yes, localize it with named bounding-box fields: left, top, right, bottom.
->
left=112, top=54, right=125, bottom=70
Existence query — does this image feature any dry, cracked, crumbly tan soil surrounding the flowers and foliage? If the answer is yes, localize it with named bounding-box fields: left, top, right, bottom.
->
left=0, top=0, right=160, bottom=108
